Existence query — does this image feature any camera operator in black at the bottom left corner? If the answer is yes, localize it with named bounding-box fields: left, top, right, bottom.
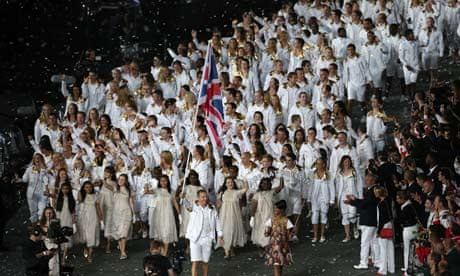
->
left=22, top=225, right=56, bottom=276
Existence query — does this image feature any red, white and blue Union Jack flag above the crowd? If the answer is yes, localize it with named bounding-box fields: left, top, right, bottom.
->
left=198, top=43, right=224, bottom=152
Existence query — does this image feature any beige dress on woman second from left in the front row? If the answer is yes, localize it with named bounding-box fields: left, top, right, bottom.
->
left=77, top=194, right=100, bottom=247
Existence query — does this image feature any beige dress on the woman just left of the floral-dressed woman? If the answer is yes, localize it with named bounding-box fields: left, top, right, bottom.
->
left=251, top=191, right=274, bottom=247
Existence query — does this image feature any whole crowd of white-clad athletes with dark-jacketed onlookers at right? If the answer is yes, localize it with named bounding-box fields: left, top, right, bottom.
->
left=22, top=0, right=460, bottom=276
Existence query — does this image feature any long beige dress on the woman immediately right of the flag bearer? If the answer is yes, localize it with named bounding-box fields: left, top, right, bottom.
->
left=219, top=190, right=247, bottom=250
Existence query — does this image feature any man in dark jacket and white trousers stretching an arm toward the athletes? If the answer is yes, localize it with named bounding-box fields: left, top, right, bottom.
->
left=345, top=173, right=379, bottom=269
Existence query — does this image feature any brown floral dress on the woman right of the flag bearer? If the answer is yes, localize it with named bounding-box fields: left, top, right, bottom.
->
left=265, top=216, right=294, bottom=266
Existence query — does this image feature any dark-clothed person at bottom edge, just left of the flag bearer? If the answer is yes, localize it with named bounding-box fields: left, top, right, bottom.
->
left=143, top=241, right=176, bottom=276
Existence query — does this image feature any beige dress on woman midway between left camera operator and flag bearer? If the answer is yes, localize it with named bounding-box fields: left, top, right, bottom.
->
left=112, top=186, right=133, bottom=240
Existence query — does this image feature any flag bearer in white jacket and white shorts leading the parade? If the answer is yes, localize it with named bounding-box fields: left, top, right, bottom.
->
left=185, top=190, right=224, bottom=276
